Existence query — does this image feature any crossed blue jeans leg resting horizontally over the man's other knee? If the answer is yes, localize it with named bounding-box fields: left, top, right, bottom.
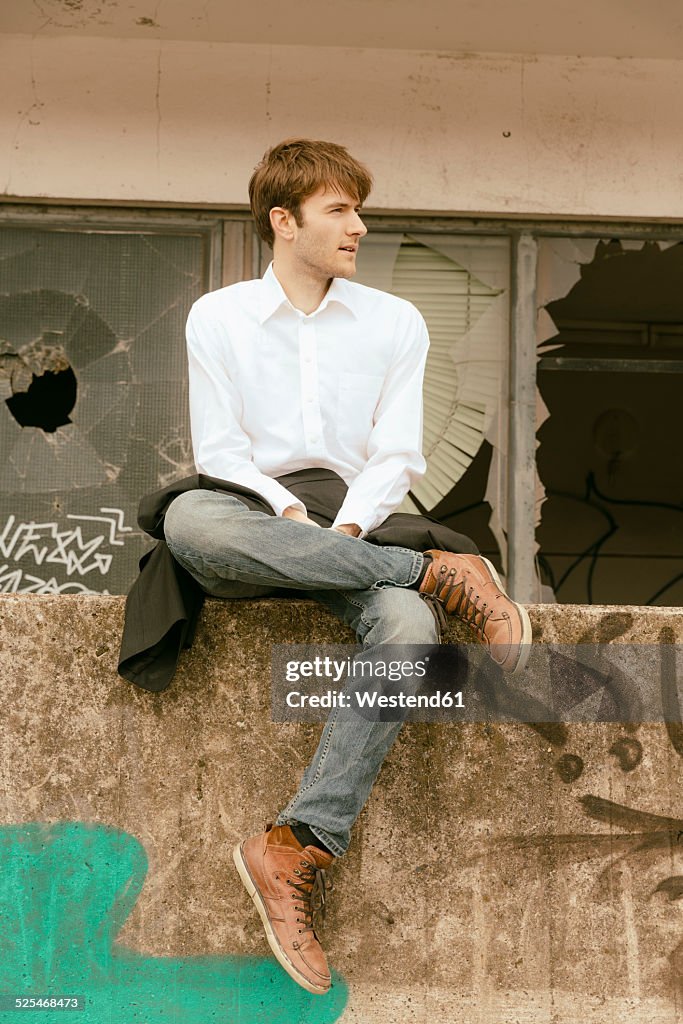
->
left=164, top=490, right=424, bottom=597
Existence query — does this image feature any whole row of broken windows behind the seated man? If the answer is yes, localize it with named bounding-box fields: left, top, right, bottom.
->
left=6, top=214, right=683, bottom=604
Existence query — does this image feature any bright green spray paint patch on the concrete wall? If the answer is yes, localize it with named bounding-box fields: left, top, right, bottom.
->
left=0, top=822, right=348, bottom=1024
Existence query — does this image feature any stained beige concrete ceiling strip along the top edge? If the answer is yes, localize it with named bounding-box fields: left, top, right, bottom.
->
left=0, top=0, right=683, bottom=58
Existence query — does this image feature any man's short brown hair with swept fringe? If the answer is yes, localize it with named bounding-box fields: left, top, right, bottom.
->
left=249, top=138, right=373, bottom=246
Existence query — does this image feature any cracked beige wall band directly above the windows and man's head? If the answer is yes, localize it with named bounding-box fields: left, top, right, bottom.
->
left=0, top=35, right=683, bottom=218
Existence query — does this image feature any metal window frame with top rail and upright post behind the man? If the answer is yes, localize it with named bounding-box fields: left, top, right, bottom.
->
left=5, top=203, right=683, bottom=602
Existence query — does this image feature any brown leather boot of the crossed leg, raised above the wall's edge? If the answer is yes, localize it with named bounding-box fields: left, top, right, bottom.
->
left=420, top=551, right=531, bottom=675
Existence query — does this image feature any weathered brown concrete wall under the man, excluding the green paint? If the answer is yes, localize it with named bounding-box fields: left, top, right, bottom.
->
left=0, top=596, right=683, bottom=1024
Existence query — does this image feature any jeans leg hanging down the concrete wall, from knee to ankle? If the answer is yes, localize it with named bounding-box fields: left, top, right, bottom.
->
left=276, top=588, right=439, bottom=856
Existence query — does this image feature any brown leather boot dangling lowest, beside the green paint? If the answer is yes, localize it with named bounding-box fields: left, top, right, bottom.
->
left=232, top=825, right=335, bottom=995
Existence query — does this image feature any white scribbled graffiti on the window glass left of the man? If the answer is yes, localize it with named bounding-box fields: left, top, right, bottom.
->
left=0, top=508, right=133, bottom=594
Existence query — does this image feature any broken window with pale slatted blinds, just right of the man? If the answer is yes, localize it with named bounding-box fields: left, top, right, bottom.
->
left=354, top=231, right=510, bottom=561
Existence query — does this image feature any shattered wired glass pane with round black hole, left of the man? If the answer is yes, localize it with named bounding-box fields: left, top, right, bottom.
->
left=0, top=227, right=208, bottom=594
